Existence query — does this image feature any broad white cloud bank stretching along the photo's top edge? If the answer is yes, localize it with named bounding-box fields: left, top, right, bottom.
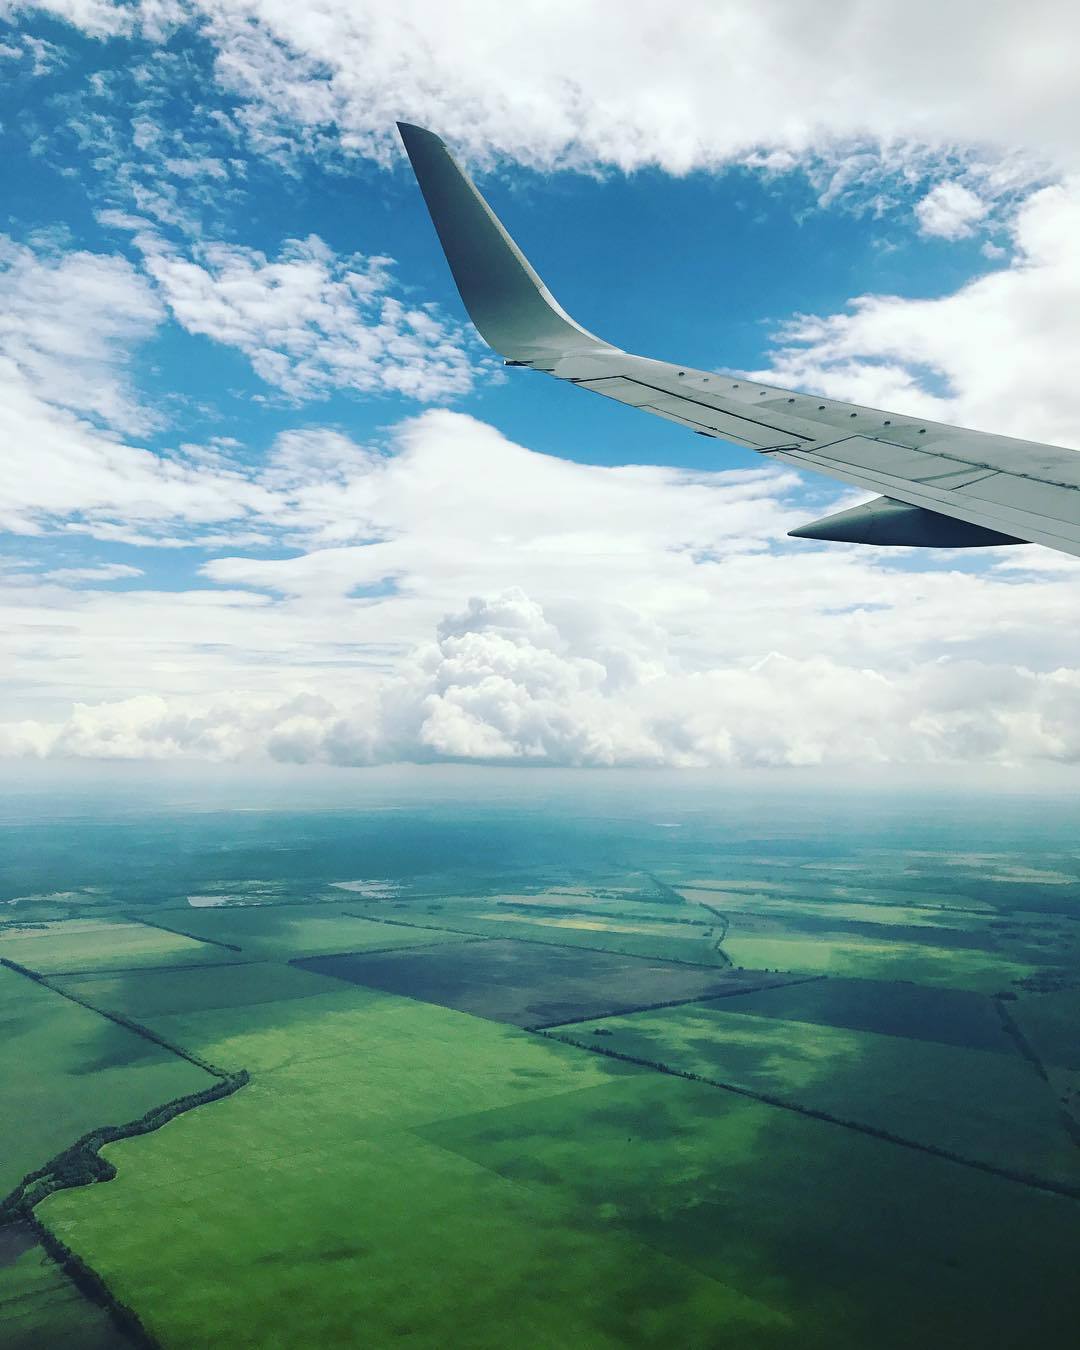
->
left=8, top=0, right=1080, bottom=194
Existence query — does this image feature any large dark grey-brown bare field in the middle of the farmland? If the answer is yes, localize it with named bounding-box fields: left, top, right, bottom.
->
left=302, top=941, right=799, bottom=1026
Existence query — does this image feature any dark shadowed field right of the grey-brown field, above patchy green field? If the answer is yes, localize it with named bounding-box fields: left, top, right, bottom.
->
left=707, top=976, right=1015, bottom=1053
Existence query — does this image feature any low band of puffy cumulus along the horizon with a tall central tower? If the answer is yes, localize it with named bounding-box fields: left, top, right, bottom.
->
left=10, top=590, right=1080, bottom=768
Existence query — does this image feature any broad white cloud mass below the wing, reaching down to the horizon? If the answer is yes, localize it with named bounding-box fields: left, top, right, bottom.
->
left=0, top=412, right=1080, bottom=765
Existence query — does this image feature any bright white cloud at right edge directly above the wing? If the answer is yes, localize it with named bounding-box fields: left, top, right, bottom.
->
left=770, top=178, right=1080, bottom=446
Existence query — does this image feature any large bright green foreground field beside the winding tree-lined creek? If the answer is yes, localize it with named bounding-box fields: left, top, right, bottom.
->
left=39, top=988, right=778, bottom=1350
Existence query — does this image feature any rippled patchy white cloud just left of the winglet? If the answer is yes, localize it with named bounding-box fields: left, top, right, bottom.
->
left=123, top=226, right=473, bottom=400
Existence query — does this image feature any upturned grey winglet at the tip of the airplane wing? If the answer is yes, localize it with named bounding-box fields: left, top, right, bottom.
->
left=397, top=122, right=616, bottom=366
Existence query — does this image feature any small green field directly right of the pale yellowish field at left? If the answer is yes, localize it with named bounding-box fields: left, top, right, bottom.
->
left=150, top=905, right=460, bottom=959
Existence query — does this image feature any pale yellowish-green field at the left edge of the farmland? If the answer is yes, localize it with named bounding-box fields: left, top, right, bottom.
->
left=0, top=919, right=228, bottom=975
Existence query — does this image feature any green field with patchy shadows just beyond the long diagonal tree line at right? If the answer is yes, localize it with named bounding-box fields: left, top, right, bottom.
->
left=556, top=1000, right=1080, bottom=1184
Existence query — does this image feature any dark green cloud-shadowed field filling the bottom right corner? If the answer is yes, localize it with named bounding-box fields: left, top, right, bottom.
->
left=423, top=1076, right=1080, bottom=1350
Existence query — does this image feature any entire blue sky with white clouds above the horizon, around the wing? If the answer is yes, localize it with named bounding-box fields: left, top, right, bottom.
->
left=0, top=0, right=1080, bottom=782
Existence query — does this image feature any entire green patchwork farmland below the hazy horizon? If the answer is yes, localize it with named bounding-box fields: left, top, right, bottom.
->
left=0, top=790, right=1080, bottom=1347
